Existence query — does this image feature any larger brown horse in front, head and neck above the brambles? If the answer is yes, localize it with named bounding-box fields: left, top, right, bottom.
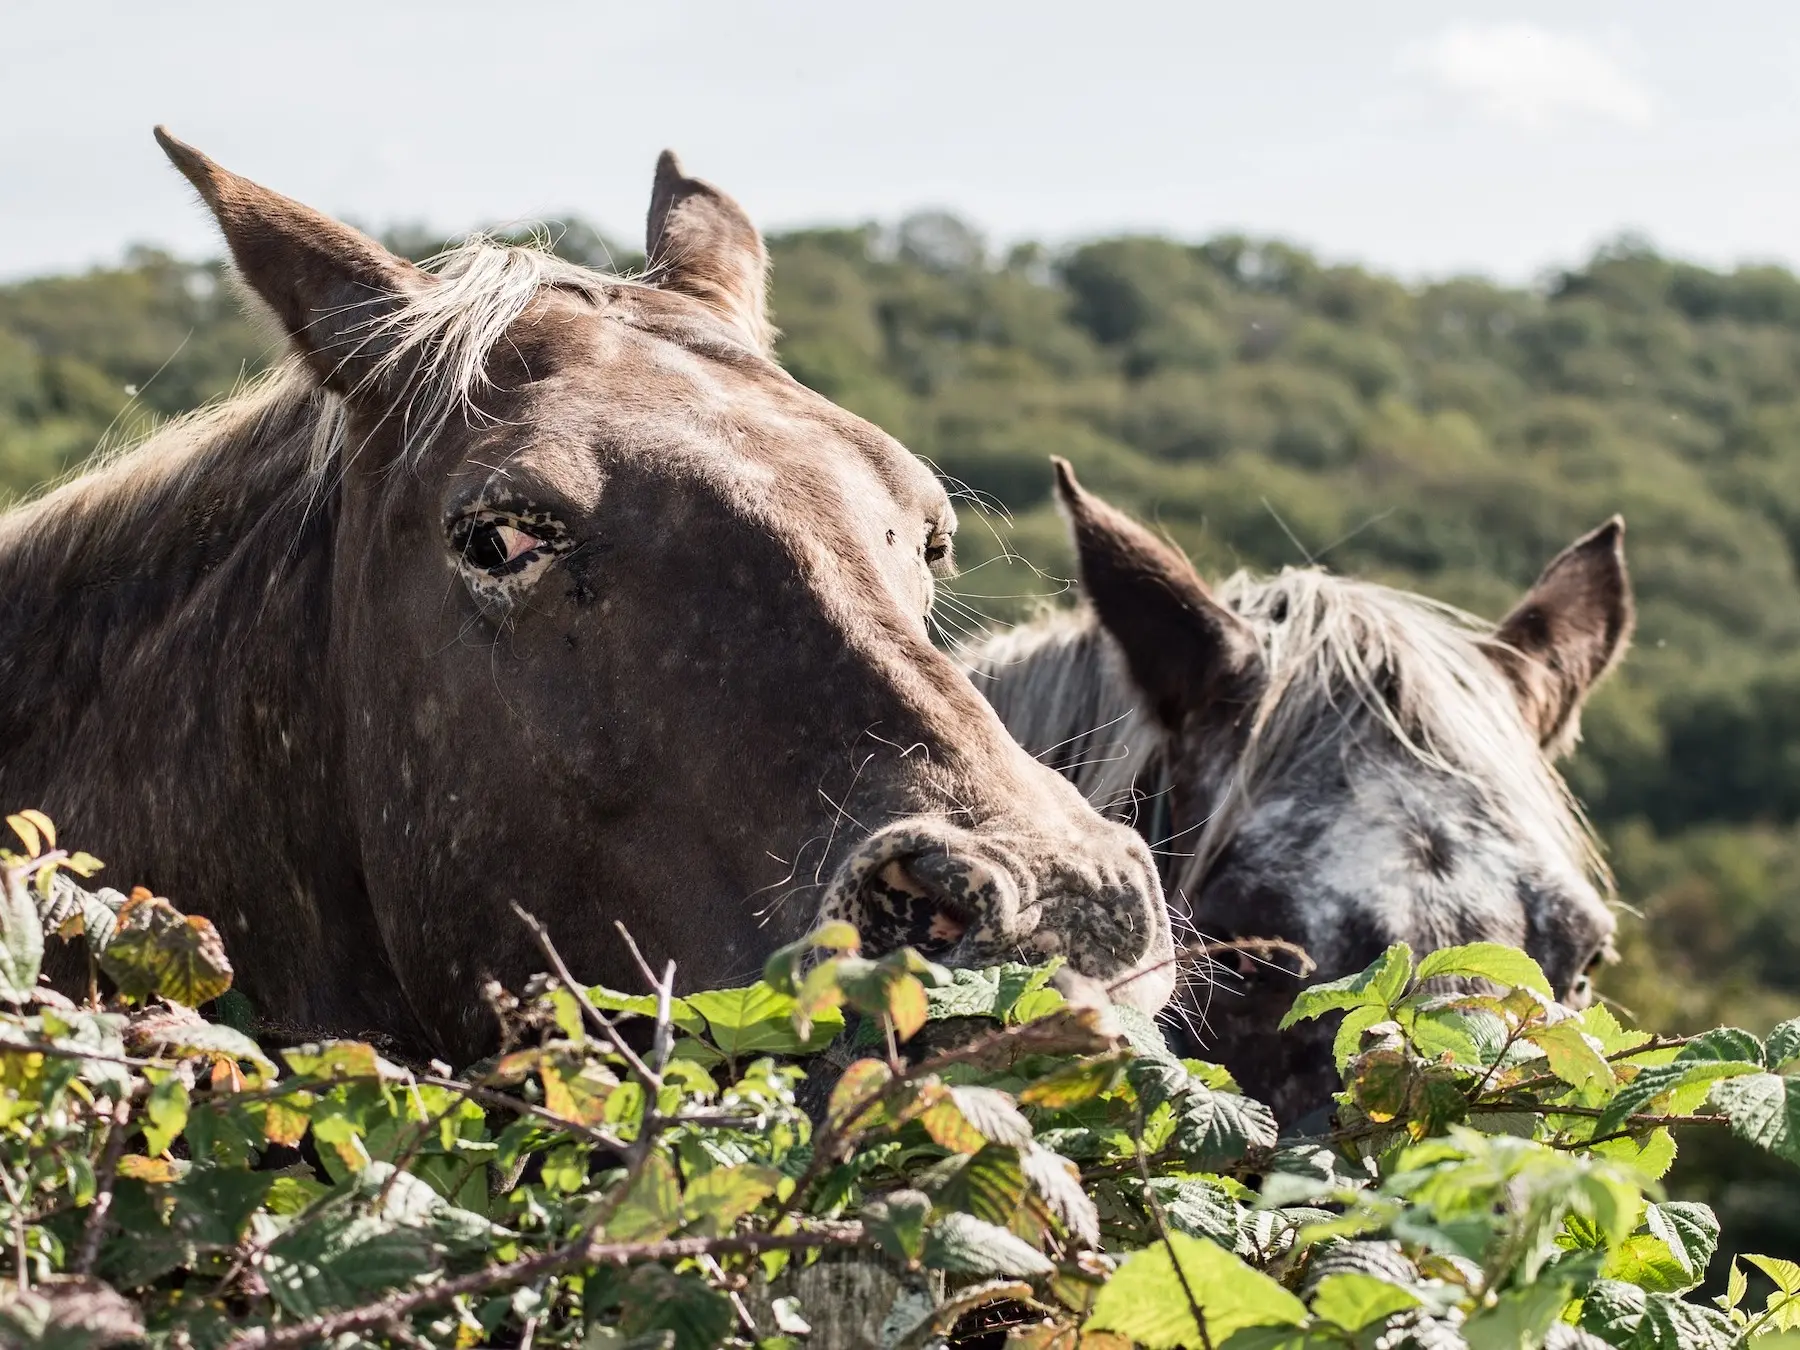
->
left=0, top=140, right=1172, bottom=1058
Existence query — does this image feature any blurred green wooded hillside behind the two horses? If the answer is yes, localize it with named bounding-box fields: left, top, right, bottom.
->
left=10, top=212, right=1800, bottom=1255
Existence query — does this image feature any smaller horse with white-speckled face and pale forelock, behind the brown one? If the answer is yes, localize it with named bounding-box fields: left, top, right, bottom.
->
left=976, top=464, right=1633, bottom=1118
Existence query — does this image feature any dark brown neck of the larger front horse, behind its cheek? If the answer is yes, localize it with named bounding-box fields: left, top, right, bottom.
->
left=0, top=378, right=352, bottom=936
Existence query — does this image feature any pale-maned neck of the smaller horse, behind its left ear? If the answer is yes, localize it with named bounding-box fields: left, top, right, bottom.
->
left=963, top=610, right=1166, bottom=824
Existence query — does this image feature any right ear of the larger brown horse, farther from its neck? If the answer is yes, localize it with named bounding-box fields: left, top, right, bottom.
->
left=644, top=149, right=776, bottom=356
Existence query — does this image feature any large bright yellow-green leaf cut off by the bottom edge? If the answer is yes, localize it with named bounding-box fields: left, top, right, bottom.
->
left=1087, top=1233, right=1307, bottom=1350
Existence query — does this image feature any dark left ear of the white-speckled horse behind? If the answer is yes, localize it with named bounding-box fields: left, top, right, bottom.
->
left=1051, top=459, right=1258, bottom=729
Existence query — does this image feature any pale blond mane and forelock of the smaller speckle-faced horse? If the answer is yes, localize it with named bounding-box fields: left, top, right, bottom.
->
left=965, top=567, right=1611, bottom=903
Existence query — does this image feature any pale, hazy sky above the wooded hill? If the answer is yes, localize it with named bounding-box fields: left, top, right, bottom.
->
left=0, top=0, right=1800, bottom=279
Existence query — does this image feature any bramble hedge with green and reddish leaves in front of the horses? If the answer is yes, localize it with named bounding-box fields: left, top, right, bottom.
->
left=0, top=812, right=1800, bottom=1350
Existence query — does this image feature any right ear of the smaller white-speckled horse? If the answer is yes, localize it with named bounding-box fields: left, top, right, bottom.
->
left=1489, top=515, right=1636, bottom=754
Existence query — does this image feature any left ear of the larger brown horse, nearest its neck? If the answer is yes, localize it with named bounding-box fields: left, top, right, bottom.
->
left=157, top=126, right=434, bottom=394
